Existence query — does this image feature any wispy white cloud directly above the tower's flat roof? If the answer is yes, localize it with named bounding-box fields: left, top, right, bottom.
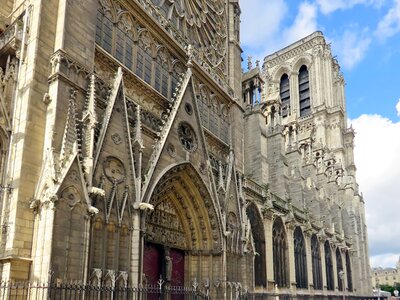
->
left=283, top=2, right=317, bottom=44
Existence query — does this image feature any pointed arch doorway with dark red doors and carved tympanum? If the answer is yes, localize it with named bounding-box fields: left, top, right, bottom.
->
left=143, top=163, right=222, bottom=286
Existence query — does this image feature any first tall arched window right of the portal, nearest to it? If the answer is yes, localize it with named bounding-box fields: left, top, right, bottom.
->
left=247, top=204, right=267, bottom=287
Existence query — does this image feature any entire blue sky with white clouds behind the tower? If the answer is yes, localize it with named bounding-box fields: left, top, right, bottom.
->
left=240, top=0, right=400, bottom=267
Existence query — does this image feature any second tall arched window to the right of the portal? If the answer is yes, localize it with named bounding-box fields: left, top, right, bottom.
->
left=272, top=218, right=289, bottom=287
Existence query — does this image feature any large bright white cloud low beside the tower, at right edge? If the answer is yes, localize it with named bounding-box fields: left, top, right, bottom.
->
left=351, top=111, right=400, bottom=267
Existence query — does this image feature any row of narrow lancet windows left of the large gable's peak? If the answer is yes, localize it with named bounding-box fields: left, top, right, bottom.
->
left=96, top=7, right=185, bottom=98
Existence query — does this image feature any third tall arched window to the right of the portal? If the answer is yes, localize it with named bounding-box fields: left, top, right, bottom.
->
left=293, top=227, right=308, bottom=289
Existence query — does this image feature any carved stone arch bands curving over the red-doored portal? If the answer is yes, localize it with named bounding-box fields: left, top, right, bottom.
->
left=145, top=162, right=223, bottom=251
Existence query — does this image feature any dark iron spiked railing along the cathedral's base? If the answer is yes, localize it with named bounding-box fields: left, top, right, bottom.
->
left=0, top=282, right=382, bottom=300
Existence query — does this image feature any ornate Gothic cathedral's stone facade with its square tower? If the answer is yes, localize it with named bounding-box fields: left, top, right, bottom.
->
left=0, top=0, right=370, bottom=299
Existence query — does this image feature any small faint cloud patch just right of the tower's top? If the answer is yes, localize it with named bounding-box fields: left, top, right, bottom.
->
left=332, top=28, right=371, bottom=70
